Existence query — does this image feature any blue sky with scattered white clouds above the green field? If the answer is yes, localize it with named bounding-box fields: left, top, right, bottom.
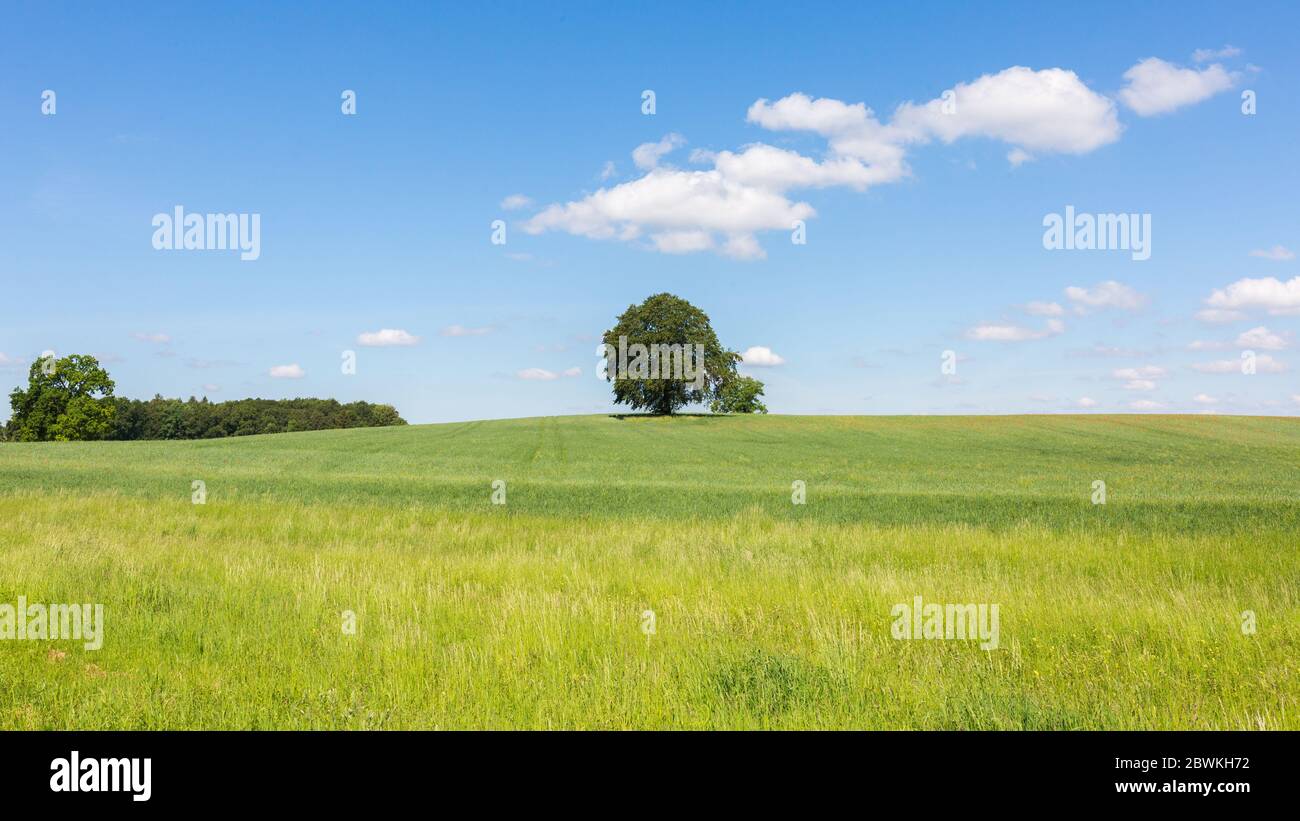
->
left=0, top=3, right=1300, bottom=422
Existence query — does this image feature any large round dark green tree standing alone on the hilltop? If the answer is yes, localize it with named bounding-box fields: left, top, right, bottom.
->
left=603, top=294, right=740, bottom=414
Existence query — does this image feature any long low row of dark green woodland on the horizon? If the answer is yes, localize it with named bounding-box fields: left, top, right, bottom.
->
left=109, top=396, right=406, bottom=439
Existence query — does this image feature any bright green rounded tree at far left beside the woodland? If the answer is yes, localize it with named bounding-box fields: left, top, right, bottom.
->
left=8, top=353, right=116, bottom=442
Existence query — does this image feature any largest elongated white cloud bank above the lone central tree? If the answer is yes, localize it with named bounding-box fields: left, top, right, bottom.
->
left=523, top=66, right=1121, bottom=260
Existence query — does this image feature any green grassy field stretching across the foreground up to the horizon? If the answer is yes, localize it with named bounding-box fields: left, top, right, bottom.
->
left=0, top=416, right=1300, bottom=729
